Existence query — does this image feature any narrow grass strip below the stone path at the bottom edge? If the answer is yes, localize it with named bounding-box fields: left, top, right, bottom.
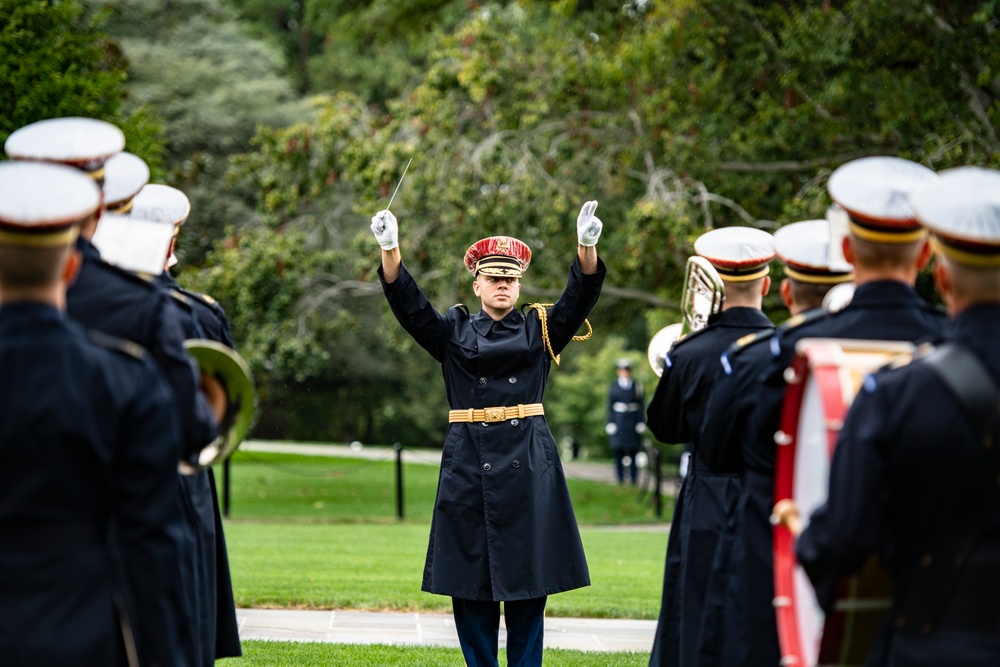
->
left=216, top=641, right=649, bottom=667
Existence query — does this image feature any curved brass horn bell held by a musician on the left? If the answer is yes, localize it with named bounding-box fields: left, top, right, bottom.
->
left=182, top=338, right=255, bottom=472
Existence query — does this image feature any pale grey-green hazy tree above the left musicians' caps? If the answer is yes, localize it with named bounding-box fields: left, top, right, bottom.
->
left=85, top=0, right=309, bottom=265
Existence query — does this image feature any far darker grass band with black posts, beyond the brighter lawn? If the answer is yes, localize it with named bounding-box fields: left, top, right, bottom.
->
left=226, top=450, right=673, bottom=526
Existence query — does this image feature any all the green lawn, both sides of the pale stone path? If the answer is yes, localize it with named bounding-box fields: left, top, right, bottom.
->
left=217, top=452, right=673, bottom=667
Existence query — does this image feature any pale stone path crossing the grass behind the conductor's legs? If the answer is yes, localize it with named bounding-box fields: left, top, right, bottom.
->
left=236, top=609, right=656, bottom=651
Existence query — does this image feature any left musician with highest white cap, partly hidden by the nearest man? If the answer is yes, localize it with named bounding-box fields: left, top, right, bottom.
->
left=5, top=118, right=226, bottom=665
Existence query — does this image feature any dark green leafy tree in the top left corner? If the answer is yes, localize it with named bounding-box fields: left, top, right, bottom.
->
left=0, top=0, right=162, bottom=169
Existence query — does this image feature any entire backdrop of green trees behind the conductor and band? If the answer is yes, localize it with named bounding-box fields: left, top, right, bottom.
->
left=0, top=0, right=1000, bottom=450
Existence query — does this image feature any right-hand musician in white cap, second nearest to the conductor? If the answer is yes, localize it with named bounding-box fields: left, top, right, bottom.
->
left=699, top=220, right=854, bottom=667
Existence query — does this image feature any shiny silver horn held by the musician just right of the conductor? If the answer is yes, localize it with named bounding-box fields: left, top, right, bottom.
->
left=646, top=255, right=726, bottom=377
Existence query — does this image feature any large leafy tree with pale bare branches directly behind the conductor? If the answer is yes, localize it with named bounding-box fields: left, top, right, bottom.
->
left=229, top=0, right=1000, bottom=448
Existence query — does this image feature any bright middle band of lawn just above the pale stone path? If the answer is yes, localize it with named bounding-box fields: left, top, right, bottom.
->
left=226, top=522, right=667, bottom=619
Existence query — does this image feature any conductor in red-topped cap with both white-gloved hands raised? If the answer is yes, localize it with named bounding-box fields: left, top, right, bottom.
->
left=372, top=202, right=605, bottom=667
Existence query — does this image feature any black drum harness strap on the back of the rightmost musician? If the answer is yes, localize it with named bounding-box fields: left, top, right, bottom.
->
left=896, top=344, right=1000, bottom=634
